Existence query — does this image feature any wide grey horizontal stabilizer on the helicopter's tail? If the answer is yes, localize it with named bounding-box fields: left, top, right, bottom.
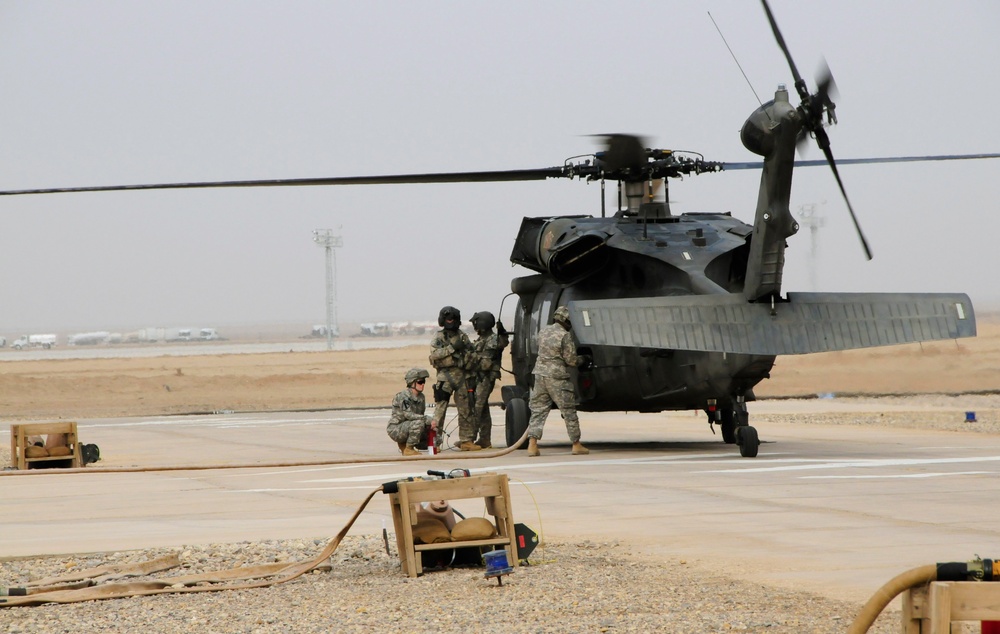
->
left=568, top=293, right=976, bottom=355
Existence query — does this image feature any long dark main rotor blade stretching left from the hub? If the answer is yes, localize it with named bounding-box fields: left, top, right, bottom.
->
left=0, top=167, right=566, bottom=196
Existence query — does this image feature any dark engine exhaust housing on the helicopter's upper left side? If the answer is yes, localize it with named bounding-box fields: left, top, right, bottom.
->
left=510, top=217, right=611, bottom=284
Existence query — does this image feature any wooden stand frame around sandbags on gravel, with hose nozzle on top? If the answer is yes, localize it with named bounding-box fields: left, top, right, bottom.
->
left=389, top=473, right=517, bottom=577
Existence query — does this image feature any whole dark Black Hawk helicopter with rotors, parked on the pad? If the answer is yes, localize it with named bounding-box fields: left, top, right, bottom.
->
left=0, top=0, right=1000, bottom=457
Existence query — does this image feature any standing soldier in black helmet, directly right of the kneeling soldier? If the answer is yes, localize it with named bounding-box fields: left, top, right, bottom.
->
left=430, top=306, right=482, bottom=451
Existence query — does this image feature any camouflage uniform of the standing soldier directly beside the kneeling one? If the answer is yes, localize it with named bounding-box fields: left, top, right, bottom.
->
left=430, top=329, right=476, bottom=444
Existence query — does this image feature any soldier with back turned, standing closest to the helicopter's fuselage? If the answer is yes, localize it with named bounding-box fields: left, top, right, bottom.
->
left=528, top=306, right=590, bottom=456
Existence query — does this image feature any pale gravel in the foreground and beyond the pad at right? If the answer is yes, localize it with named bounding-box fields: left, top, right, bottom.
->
left=0, top=395, right=1000, bottom=634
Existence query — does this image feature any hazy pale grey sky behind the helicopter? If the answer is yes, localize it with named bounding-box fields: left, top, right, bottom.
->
left=0, top=0, right=1000, bottom=337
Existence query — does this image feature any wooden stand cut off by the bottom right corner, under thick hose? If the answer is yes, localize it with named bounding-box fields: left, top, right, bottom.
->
left=902, top=581, right=1000, bottom=634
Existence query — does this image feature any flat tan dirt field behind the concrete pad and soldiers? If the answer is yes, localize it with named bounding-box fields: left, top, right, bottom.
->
left=0, top=314, right=1000, bottom=420
